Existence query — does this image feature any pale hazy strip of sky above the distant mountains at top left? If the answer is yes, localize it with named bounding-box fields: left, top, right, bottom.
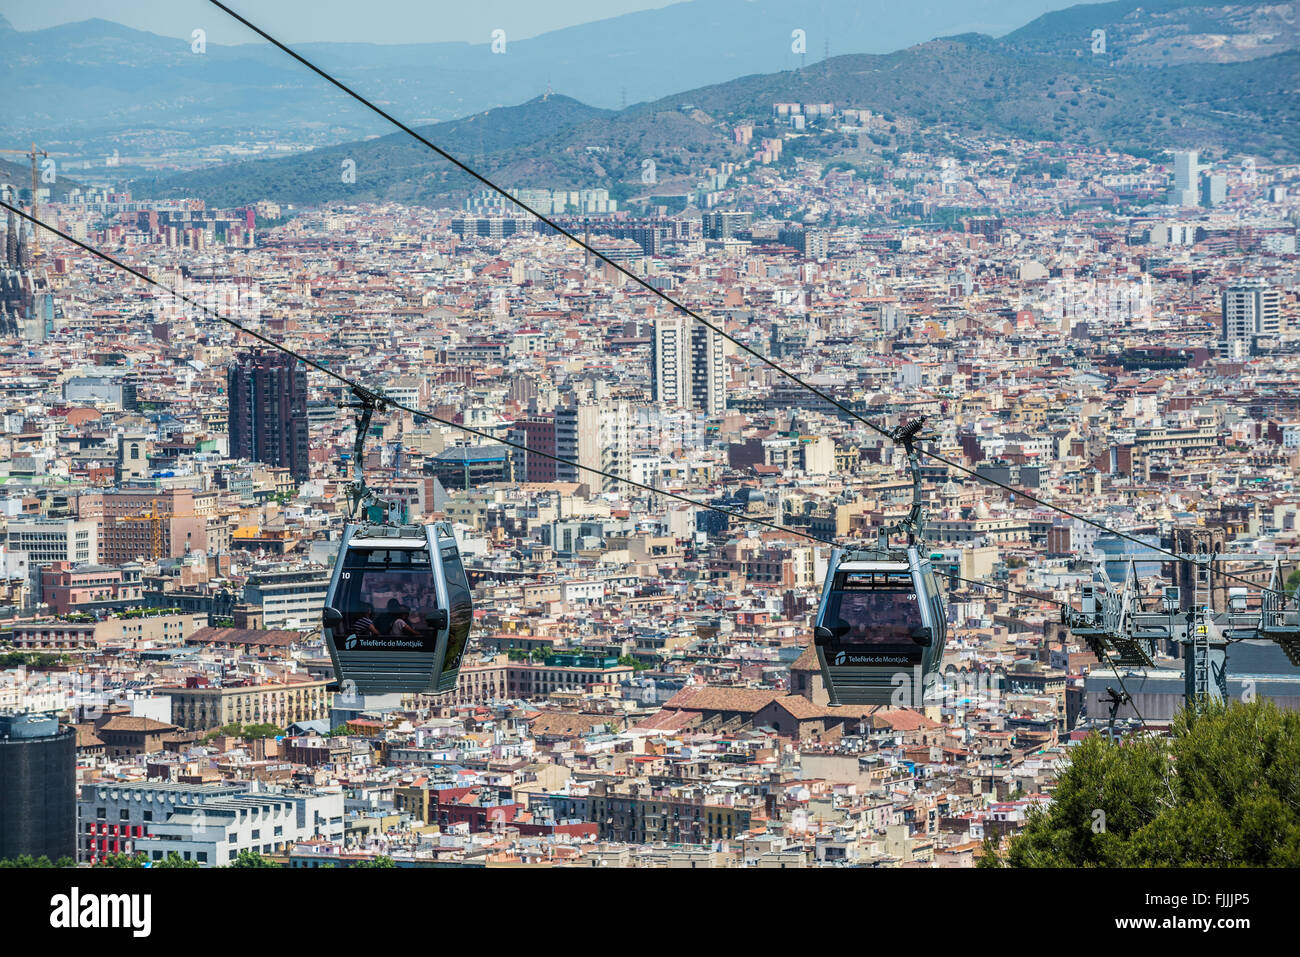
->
left=0, top=0, right=679, bottom=43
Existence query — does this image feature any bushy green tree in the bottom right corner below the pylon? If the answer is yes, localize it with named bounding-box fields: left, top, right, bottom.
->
left=980, top=701, right=1300, bottom=867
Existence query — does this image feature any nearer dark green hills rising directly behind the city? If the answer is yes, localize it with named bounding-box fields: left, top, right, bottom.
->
left=124, top=13, right=1300, bottom=204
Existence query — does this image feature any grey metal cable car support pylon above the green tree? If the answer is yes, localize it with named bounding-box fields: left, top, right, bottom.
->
left=1061, top=553, right=1300, bottom=707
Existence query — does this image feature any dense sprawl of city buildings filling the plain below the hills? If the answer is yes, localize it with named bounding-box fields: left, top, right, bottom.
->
left=0, top=9, right=1300, bottom=867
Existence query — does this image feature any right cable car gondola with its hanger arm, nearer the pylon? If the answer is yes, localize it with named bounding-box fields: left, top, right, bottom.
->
left=813, top=420, right=948, bottom=707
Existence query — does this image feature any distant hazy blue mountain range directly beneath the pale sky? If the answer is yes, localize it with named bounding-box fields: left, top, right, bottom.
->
left=0, top=0, right=1107, bottom=153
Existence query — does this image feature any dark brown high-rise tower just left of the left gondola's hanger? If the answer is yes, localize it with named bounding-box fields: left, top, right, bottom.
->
left=226, top=348, right=311, bottom=481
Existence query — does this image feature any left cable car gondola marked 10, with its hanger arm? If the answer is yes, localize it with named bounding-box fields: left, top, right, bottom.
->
left=322, top=390, right=473, bottom=694
